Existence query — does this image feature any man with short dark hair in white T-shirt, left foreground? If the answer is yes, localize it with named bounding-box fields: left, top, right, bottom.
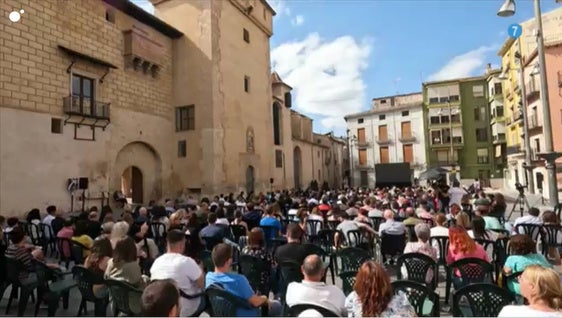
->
left=150, top=230, right=205, bottom=317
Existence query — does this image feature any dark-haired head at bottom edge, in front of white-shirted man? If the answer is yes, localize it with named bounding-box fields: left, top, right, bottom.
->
left=141, top=279, right=179, bottom=317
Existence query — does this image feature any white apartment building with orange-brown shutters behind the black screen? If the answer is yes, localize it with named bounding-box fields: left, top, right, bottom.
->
left=345, top=93, right=426, bottom=187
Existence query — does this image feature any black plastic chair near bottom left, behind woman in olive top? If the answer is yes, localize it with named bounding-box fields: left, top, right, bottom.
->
left=105, top=279, right=142, bottom=317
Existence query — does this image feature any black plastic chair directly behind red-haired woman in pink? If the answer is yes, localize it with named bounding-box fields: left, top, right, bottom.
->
left=445, top=258, right=494, bottom=304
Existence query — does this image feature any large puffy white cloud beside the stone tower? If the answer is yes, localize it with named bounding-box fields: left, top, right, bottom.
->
left=271, top=33, right=372, bottom=132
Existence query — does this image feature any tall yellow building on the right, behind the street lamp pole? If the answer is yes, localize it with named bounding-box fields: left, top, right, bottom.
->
left=497, top=8, right=562, bottom=188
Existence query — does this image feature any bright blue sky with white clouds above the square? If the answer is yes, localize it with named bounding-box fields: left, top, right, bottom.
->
left=133, top=0, right=560, bottom=135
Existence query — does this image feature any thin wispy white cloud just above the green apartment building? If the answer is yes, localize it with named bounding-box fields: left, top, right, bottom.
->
left=428, top=46, right=496, bottom=81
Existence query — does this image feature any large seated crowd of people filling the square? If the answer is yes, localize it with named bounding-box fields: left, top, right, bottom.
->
left=0, top=185, right=562, bottom=317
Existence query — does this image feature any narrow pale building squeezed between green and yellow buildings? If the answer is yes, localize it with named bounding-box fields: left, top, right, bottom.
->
left=486, top=64, right=507, bottom=179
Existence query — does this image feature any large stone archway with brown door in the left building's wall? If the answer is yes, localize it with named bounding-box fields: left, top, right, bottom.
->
left=110, top=141, right=162, bottom=203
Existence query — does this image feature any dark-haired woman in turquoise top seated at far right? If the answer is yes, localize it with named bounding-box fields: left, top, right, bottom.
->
left=503, top=234, right=552, bottom=295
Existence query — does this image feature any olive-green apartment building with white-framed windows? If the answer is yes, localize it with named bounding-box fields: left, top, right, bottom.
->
left=423, top=76, right=495, bottom=185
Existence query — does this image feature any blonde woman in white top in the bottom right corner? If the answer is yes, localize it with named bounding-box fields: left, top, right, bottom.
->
left=498, top=265, right=562, bottom=317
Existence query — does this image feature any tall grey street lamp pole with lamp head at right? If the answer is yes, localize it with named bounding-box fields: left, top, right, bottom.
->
left=498, top=0, right=562, bottom=206
